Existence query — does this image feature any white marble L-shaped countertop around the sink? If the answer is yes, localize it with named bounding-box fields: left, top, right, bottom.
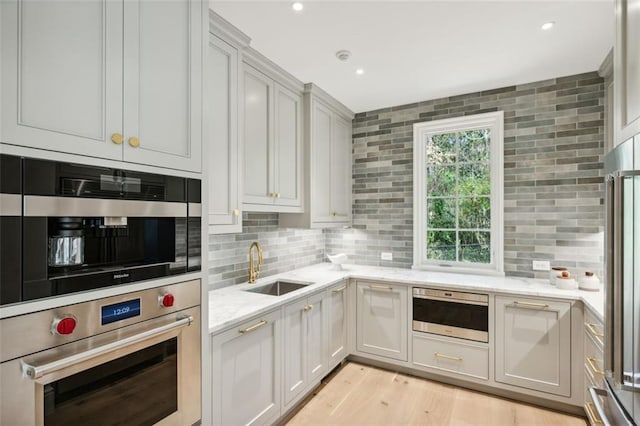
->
left=209, top=263, right=604, bottom=333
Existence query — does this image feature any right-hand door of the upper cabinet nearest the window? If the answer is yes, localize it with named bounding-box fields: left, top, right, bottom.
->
left=331, top=115, right=351, bottom=222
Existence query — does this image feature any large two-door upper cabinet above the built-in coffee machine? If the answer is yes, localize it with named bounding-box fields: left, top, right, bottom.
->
left=0, top=0, right=204, bottom=172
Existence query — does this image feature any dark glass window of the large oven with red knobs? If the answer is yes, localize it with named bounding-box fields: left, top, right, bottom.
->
left=44, top=338, right=178, bottom=426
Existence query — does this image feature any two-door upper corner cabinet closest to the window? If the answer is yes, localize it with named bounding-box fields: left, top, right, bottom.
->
left=280, top=84, right=353, bottom=228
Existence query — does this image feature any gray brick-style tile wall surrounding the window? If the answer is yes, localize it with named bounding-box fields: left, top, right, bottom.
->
left=325, top=72, right=604, bottom=278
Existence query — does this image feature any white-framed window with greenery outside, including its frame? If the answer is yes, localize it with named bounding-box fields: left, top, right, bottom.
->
left=413, top=111, right=504, bottom=274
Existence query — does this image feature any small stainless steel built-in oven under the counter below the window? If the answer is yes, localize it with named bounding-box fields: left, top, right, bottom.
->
left=413, top=287, right=489, bottom=342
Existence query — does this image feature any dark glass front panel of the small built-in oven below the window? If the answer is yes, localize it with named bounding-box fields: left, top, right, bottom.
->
left=413, top=298, right=489, bottom=331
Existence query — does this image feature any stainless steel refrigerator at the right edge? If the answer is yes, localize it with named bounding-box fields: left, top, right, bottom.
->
left=590, top=135, right=640, bottom=425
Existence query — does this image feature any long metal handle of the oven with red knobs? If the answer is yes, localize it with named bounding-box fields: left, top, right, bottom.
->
left=21, top=315, right=193, bottom=380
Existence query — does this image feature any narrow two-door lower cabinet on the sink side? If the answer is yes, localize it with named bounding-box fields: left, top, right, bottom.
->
left=283, top=292, right=327, bottom=409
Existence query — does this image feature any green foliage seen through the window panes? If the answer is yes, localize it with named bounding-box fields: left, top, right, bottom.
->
left=425, top=129, right=491, bottom=264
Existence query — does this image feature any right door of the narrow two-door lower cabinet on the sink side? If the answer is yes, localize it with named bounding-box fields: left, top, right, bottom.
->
left=306, top=292, right=327, bottom=383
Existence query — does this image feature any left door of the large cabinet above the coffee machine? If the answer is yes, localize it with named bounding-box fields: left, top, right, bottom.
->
left=0, top=0, right=123, bottom=160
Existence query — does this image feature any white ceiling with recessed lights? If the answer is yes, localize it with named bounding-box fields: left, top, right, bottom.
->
left=210, top=0, right=614, bottom=112
